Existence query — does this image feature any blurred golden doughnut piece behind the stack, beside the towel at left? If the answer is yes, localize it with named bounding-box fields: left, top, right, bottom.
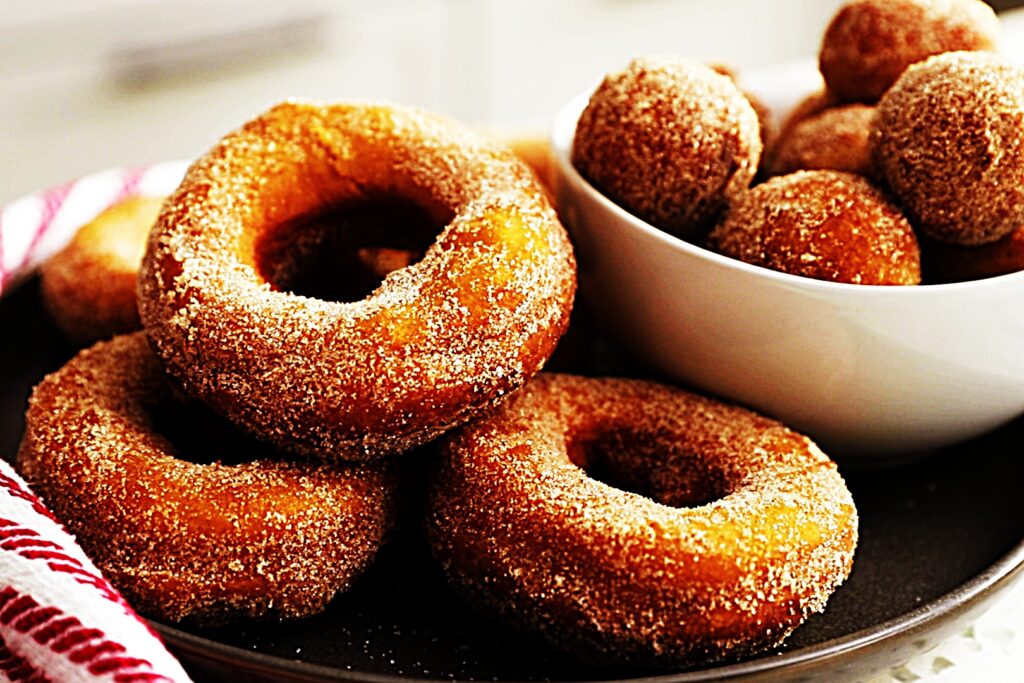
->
left=40, top=197, right=164, bottom=344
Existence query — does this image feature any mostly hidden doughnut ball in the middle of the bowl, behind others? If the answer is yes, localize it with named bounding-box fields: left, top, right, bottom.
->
left=768, top=103, right=874, bottom=176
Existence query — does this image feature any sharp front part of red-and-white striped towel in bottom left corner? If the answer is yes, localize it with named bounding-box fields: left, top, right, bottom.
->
left=0, top=461, right=189, bottom=683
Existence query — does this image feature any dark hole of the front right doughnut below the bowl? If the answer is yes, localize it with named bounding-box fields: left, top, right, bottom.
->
left=568, top=428, right=729, bottom=508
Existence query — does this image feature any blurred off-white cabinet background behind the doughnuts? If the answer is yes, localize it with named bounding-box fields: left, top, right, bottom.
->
left=0, top=0, right=1015, bottom=204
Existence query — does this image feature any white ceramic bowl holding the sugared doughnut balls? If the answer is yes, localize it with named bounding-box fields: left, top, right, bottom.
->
left=552, top=68, right=1024, bottom=465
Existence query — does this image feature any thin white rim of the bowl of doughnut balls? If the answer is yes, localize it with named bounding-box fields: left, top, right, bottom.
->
left=549, top=88, right=1024, bottom=298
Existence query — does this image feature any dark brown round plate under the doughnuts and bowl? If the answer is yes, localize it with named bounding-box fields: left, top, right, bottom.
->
left=0, top=282, right=1024, bottom=683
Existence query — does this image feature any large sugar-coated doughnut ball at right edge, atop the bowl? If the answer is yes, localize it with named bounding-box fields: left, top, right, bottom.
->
left=870, top=52, right=1024, bottom=245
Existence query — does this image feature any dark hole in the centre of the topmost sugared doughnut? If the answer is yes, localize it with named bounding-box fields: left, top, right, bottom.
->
left=256, top=194, right=453, bottom=301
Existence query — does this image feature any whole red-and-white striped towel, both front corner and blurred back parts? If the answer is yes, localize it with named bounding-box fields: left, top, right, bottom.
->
left=0, top=162, right=189, bottom=683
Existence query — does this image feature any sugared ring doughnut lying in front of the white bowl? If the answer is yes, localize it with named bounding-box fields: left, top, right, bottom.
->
left=427, top=374, right=857, bottom=667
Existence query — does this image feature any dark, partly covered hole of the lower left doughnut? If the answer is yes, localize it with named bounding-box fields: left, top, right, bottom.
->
left=152, top=398, right=282, bottom=465
